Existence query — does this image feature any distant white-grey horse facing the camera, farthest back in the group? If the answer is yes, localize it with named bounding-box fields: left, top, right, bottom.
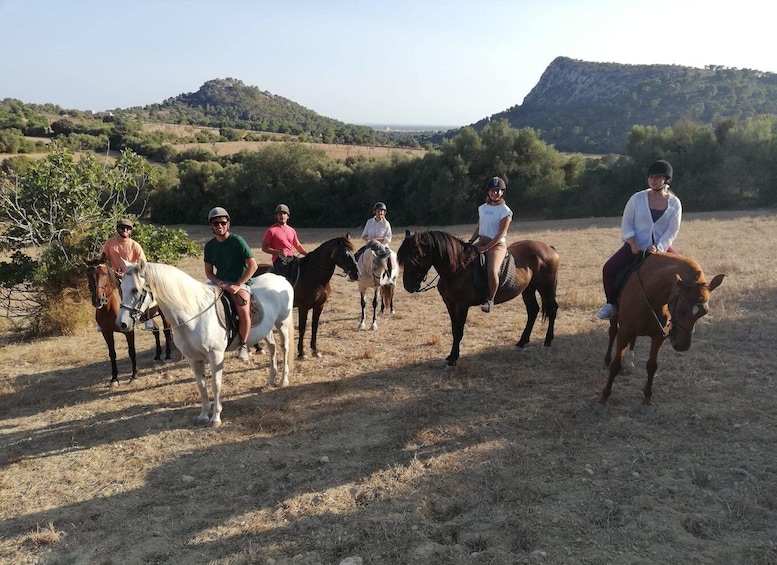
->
left=358, top=240, right=398, bottom=330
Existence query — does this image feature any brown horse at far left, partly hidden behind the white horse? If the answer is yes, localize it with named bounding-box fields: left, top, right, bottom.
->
left=85, top=257, right=173, bottom=387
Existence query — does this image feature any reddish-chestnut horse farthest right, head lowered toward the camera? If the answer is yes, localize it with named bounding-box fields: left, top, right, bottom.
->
left=596, top=253, right=725, bottom=413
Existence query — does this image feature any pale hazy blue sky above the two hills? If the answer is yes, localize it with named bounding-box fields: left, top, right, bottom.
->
left=0, top=0, right=777, bottom=126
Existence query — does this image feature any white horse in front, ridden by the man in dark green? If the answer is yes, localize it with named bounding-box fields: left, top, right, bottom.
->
left=116, top=261, right=294, bottom=428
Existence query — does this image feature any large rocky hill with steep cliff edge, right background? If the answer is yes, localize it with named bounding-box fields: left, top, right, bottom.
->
left=472, top=57, right=777, bottom=153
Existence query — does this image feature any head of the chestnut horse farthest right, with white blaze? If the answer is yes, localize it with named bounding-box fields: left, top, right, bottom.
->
left=668, top=275, right=725, bottom=351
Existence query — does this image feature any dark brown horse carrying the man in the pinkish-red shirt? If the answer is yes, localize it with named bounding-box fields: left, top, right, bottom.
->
left=256, top=234, right=359, bottom=359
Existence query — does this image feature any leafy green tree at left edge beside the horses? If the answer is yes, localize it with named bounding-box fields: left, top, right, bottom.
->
left=0, top=144, right=199, bottom=332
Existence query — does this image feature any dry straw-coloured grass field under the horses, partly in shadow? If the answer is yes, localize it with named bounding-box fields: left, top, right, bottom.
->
left=0, top=211, right=777, bottom=565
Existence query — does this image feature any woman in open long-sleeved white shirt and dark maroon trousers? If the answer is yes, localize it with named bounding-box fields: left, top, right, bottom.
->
left=596, top=159, right=683, bottom=320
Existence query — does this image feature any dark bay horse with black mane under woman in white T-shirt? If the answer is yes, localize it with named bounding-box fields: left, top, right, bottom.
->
left=397, top=231, right=559, bottom=371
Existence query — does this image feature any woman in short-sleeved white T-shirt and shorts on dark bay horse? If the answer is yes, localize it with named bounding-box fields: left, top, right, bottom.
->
left=469, top=177, right=513, bottom=312
